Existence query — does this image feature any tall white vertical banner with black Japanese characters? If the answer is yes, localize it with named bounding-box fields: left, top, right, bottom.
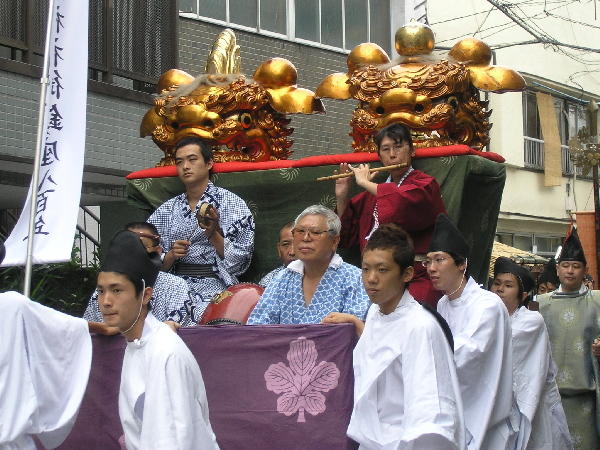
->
left=2, top=0, right=88, bottom=266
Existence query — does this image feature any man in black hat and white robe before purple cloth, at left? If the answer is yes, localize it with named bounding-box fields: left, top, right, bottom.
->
left=97, top=231, right=218, bottom=450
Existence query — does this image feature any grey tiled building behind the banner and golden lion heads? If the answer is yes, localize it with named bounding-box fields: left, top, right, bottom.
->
left=0, top=0, right=418, bottom=248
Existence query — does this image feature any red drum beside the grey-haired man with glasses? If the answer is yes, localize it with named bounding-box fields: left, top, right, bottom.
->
left=198, top=283, right=265, bottom=325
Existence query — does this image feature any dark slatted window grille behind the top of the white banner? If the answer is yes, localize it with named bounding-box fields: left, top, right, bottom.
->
left=0, top=0, right=178, bottom=92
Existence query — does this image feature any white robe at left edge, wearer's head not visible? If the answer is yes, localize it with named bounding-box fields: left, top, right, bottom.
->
left=0, top=292, right=92, bottom=450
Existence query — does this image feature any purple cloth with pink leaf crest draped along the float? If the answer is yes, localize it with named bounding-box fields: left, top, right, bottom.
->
left=59, top=324, right=356, bottom=450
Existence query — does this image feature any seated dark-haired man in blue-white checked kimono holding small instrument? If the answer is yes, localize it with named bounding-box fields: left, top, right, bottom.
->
left=148, top=137, right=254, bottom=323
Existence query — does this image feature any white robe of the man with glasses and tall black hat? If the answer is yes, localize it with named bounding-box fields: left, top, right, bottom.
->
left=437, top=278, right=518, bottom=450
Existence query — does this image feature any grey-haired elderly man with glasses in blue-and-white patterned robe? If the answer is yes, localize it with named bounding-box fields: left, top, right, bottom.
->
left=248, top=205, right=369, bottom=325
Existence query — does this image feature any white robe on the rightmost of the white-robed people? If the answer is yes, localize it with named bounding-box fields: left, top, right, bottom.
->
left=511, top=307, right=573, bottom=450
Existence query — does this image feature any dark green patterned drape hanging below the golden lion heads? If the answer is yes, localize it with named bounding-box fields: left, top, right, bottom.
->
left=127, top=155, right=506, bottom=283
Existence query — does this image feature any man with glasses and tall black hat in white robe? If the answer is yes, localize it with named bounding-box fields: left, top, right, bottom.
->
left=424, top=214, right=518, bottom=450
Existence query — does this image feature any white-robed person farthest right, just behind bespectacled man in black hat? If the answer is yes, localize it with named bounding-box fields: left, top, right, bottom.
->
left=491, top=257, right=573, bottom=450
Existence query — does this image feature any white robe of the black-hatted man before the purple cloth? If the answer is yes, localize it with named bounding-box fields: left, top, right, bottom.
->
left=119, top=313, right=219, bottom=450
